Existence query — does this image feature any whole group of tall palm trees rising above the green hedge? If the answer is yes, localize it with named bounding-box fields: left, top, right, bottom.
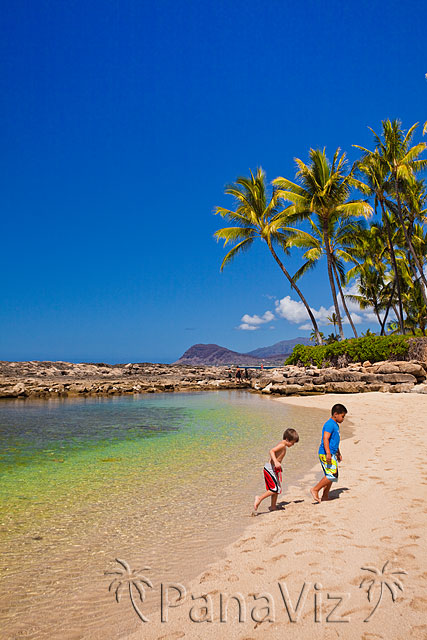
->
left=215, top=120, right=427, bottom=344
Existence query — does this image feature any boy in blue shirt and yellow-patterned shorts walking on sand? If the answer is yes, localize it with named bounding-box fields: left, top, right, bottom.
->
left=310, top=404, right=347, bottom=502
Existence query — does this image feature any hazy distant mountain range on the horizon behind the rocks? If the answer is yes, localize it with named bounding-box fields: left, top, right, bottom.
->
left=173, top=338, right=309, bottom=366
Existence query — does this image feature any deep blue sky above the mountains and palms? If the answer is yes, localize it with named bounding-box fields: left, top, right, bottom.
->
left=0, top=0, right=427, bottom=362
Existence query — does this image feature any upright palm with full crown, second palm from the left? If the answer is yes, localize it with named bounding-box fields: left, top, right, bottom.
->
left=273, top=149, right=372, bottom=339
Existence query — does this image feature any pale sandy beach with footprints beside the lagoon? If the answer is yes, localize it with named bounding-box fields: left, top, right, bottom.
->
left=120, top=393, right=427, bottom=640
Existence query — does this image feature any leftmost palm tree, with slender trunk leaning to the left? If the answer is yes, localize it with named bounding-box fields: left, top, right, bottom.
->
left=215, top=168, right=322, bottom=344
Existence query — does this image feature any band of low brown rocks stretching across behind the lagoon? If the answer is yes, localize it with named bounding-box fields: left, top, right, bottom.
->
left=0, top=360, right=427, bottom=398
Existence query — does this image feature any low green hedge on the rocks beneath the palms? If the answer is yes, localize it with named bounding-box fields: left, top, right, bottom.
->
left=285, top=336, right=409, bottom=367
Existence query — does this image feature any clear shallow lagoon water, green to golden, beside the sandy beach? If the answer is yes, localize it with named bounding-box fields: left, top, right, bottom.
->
left=0, top=391, right=327, bottom=639
